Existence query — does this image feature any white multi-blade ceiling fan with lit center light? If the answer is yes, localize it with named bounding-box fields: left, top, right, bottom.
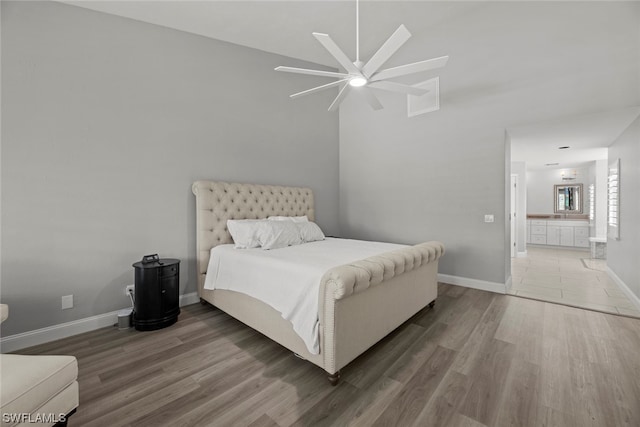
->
left=275, top=0, right=449, bottom=111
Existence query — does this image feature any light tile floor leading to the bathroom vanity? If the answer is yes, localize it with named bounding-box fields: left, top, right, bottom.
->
left=509, top=246, right=640, bottom=317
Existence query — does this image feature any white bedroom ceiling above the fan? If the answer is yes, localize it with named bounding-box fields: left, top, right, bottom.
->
left=61, top=0, right=478, bottom=67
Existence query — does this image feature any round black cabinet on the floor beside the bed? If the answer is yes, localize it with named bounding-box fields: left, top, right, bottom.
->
left=133, top=258, right=180, bottom=331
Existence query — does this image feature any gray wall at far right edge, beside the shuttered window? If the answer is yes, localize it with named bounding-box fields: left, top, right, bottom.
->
left=607, top=118, right=640, bottom=298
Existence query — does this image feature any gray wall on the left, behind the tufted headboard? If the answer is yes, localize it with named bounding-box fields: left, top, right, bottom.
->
left=1, top=1, right=338, bottom=335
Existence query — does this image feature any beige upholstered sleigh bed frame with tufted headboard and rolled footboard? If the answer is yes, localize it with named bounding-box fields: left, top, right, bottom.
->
left=192, top=181, right=444, bottom=385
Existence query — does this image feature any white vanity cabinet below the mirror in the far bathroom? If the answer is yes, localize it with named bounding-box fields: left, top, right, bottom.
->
left=527, top=219, right=589, bottom=248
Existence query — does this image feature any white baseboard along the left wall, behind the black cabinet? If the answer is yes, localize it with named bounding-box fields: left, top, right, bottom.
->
left=0, top=292, right=200, bottom=353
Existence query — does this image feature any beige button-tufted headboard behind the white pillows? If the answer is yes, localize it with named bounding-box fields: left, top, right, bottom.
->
left=191, top=181, right=315, bottom=295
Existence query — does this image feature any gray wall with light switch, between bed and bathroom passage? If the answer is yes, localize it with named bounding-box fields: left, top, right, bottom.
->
left=340, top=2, right=640, bottom=283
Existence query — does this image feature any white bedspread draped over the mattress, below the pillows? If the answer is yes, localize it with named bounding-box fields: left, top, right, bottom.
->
left=204, top=238, right=406, bottom=354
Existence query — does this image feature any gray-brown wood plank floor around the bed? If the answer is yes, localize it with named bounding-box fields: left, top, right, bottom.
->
left=20, top=284, right=640, bottom=427
